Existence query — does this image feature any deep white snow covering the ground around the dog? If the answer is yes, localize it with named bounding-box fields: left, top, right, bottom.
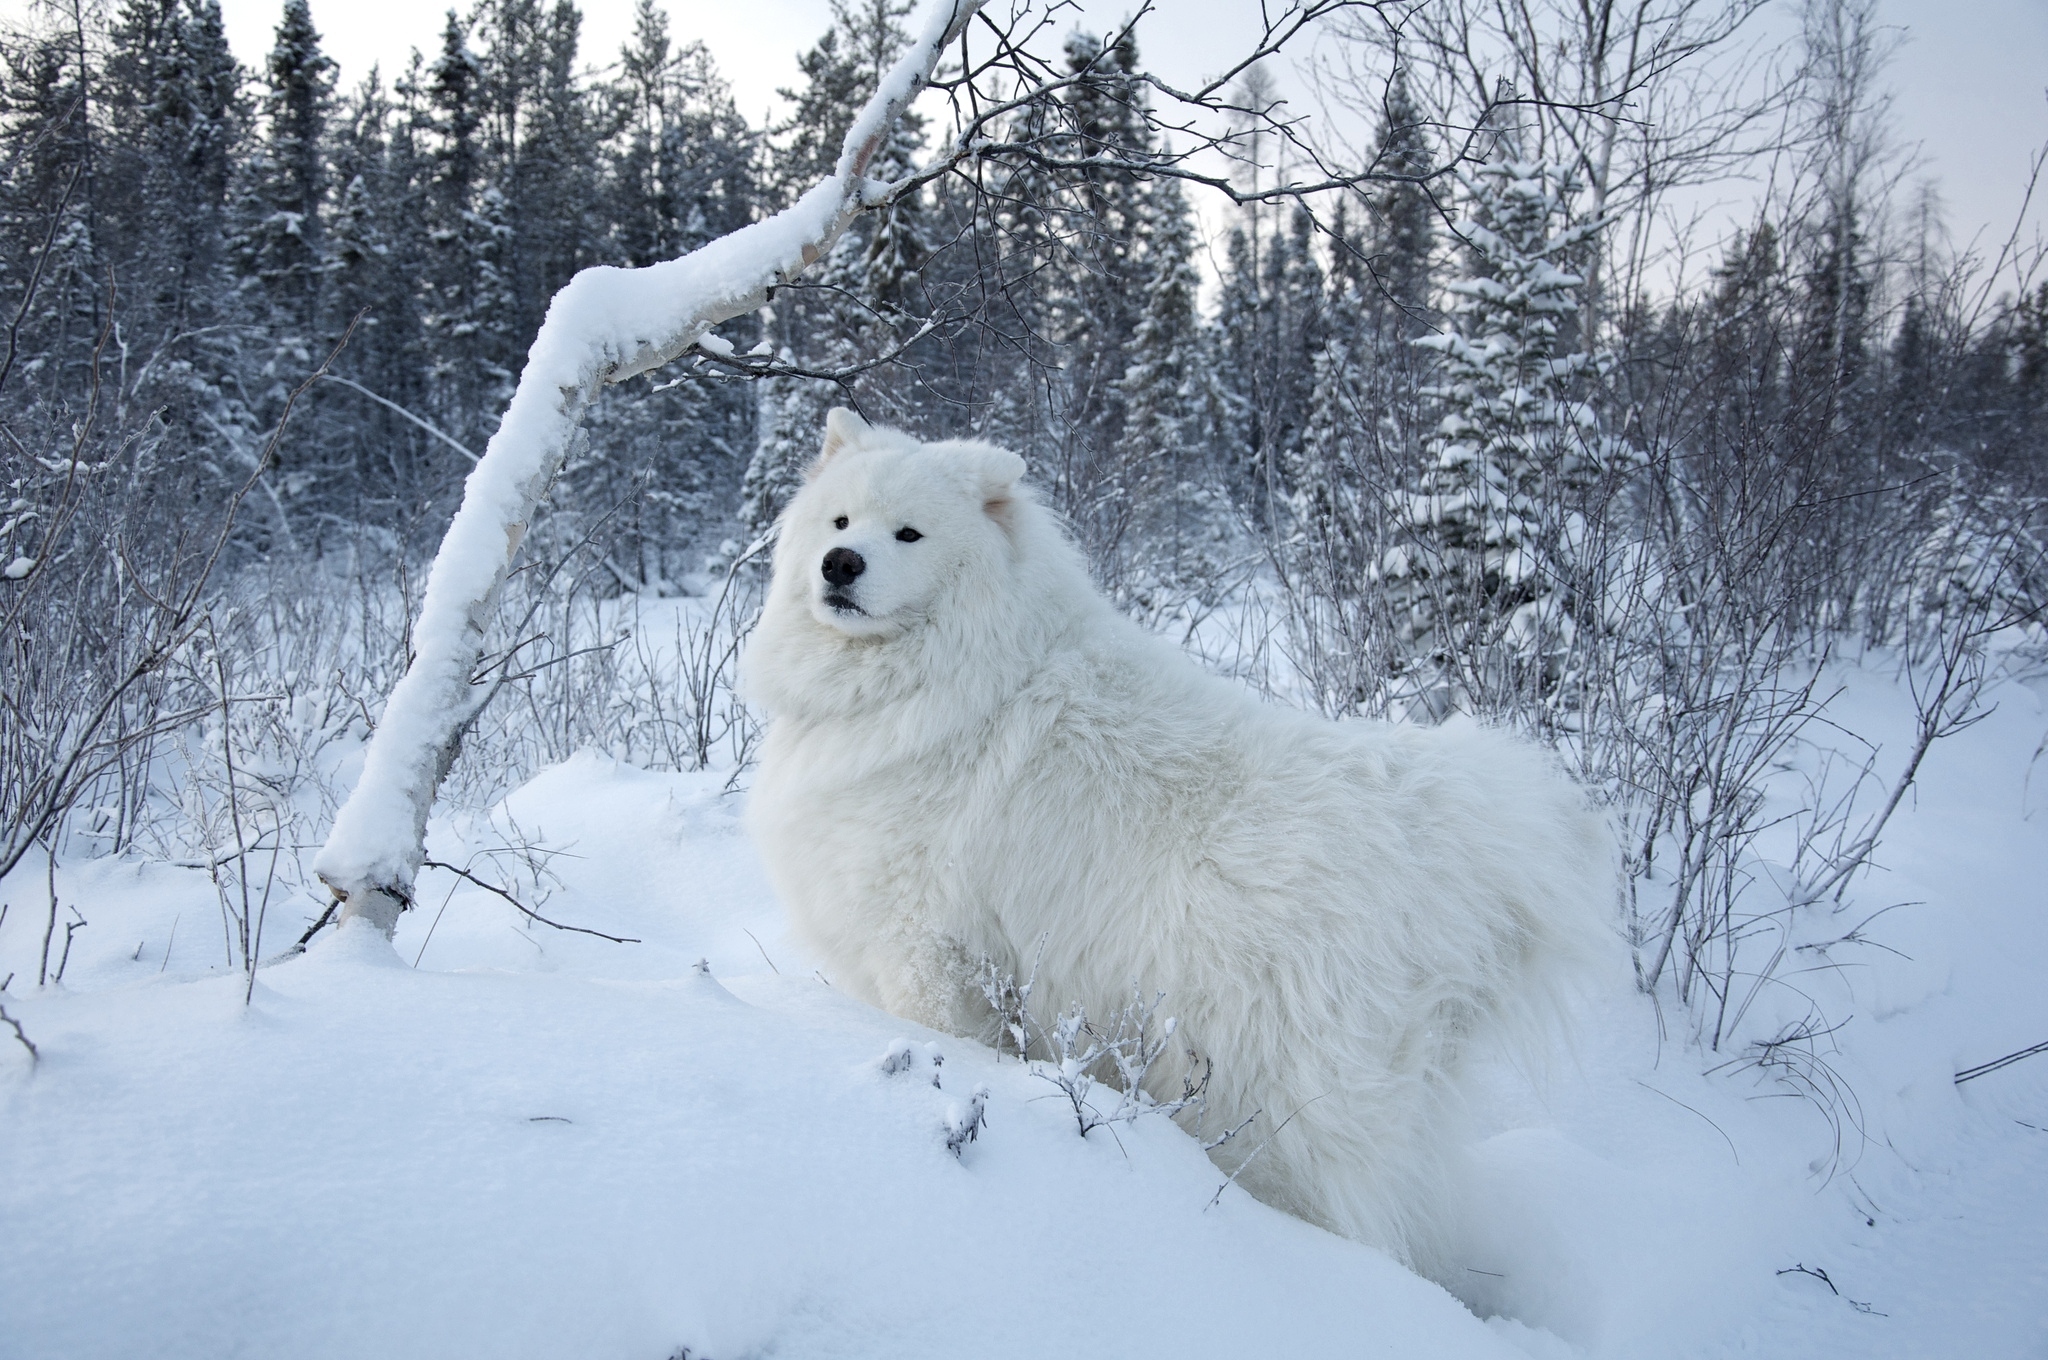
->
left=0, top=666, right=2048, bottom=1360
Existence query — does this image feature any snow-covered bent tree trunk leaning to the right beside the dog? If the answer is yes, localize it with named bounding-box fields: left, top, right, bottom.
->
left=313, top=0, right=985, bottom=934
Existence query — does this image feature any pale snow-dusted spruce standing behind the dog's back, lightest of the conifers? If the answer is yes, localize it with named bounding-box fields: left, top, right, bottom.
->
left=1378, top=160, right=1628, bottom=715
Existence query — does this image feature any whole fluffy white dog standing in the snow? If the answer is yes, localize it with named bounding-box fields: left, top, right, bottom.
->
left=743, top=412, right=1612, bottom=1270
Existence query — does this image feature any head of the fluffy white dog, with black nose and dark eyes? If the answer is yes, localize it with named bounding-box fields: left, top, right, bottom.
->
left=776, top=408, right=1024, bottom=637
